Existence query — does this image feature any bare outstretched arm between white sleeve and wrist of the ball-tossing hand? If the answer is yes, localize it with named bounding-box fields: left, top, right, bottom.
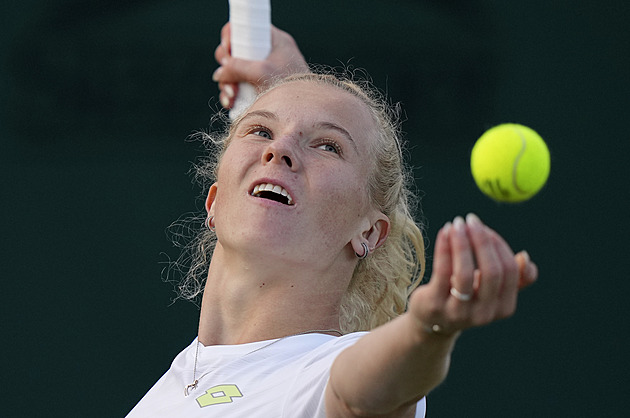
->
left=329, top=314, right=456, bottom=416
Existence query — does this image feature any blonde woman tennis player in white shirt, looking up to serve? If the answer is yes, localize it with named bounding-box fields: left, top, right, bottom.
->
left=129, top=26, right=537, bottom=418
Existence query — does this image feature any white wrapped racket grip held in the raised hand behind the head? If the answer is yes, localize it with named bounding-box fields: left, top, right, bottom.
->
left=229, top=0, right=271, bottom=120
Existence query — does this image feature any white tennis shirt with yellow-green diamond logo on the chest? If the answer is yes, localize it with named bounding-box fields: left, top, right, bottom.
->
left=127, top=332, right=426, bottom=418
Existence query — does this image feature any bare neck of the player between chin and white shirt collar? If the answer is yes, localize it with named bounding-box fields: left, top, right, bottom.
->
left=199, top=243, right=352, bottom=346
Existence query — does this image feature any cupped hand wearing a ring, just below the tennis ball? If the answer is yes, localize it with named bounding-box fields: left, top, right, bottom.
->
left=410, top=214, right=538, bottom=333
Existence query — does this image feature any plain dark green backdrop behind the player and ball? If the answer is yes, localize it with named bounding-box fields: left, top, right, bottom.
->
left=0, top=0, right=630, bottom=417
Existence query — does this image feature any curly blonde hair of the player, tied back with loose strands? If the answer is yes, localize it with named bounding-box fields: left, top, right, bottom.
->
left=170, top=73, right=425, bottom=333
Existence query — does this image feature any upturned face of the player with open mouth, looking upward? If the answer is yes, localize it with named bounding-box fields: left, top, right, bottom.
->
left=207, top=81, right=382, bottom=268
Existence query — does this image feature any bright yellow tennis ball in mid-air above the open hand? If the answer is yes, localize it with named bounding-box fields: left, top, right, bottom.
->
left=470, top=123, right=551, bottom=202
